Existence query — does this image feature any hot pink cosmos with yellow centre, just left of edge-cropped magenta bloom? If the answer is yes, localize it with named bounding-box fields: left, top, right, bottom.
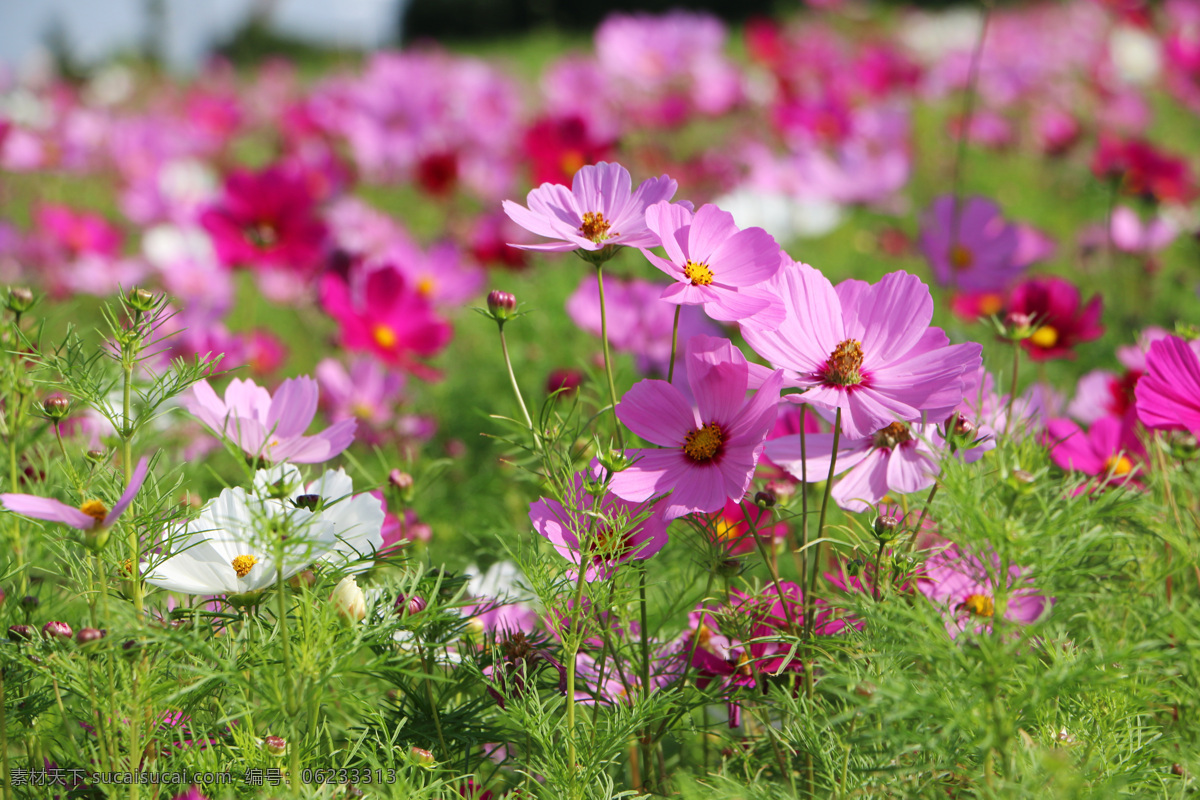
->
left=1045, top=414, right=1146, bottom=486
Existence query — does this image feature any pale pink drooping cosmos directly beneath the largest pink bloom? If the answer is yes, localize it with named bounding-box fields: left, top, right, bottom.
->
left=767, top=422, right=945, bottom=512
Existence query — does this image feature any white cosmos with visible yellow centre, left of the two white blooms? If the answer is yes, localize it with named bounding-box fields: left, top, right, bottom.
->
left=143, top=487, right=338, bottom=595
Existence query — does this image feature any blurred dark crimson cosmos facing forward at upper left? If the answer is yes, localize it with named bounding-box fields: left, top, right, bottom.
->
left=200, top=167, right=329, bottom=273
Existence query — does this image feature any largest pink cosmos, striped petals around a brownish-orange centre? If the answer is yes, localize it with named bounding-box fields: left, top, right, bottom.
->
left=742, top=264, right=983, bottom=439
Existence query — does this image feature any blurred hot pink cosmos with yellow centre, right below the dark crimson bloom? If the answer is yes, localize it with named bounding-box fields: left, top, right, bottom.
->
left=320, top=264, right=452, bottom=378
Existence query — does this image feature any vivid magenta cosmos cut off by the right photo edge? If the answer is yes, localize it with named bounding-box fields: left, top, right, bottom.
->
left=1134, top=336, right=1200, bottom=437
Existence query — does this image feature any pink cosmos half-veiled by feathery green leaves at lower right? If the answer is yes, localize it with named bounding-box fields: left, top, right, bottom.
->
left=917, top=546, right=1054, bottom=639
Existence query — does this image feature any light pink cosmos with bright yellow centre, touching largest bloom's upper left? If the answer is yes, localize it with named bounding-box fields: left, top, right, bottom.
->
left=642, top=201, right=784, bottom=325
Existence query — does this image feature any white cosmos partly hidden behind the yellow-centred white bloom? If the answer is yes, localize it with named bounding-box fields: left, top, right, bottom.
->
left=254, top=464, right=384, bottom=572
